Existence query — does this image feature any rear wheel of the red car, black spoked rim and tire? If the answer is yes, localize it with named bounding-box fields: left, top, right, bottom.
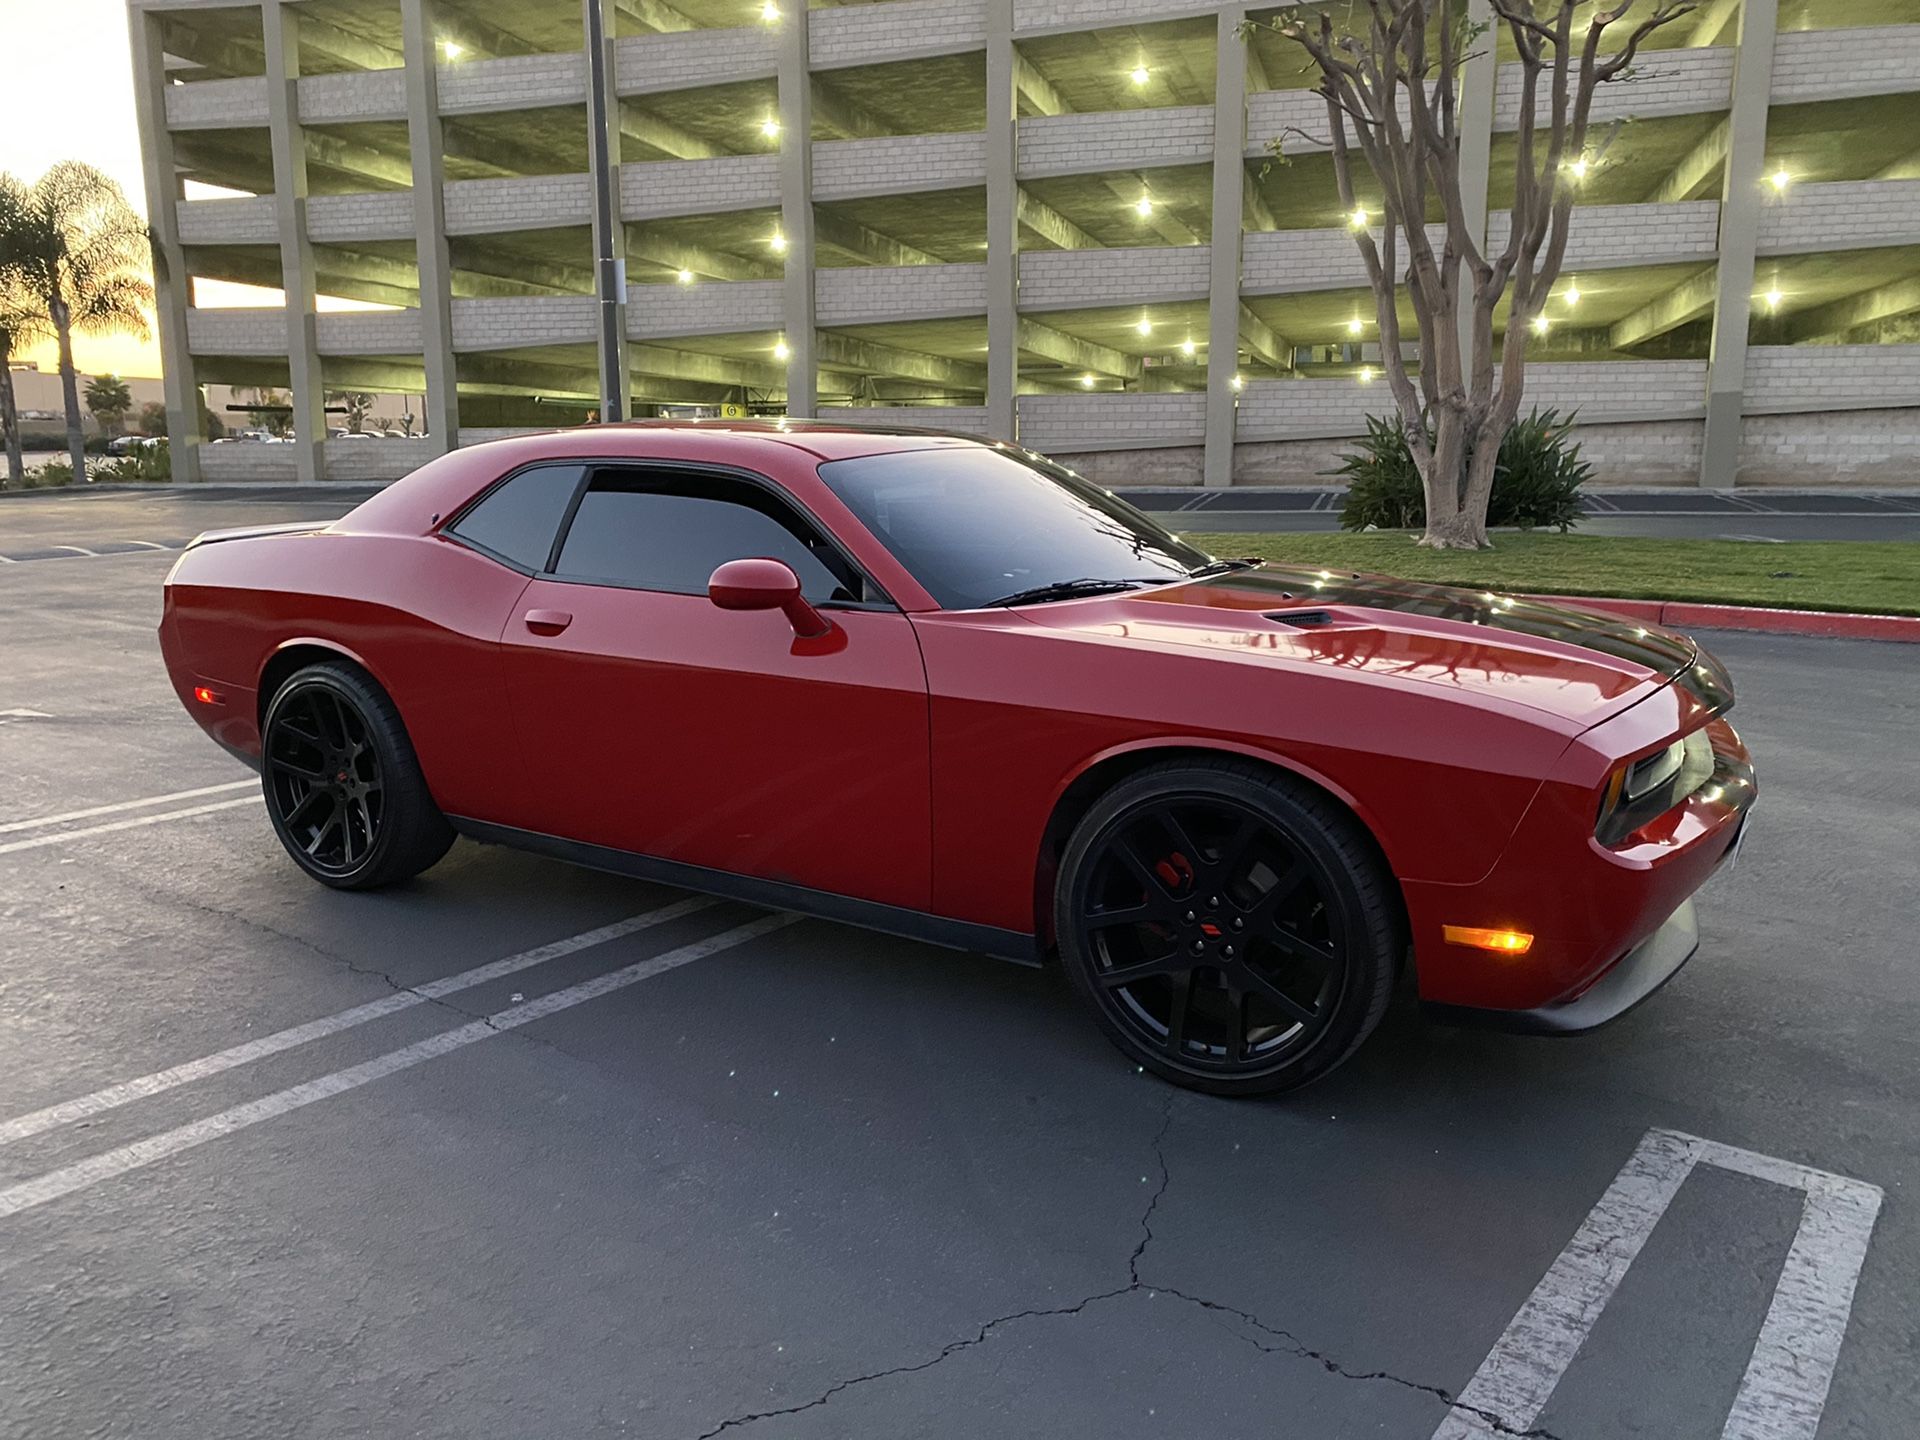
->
left=261, top=660, right=453, bottom=891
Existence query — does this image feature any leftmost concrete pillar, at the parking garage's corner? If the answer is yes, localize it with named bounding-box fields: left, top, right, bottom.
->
left=127, top=8, right=207, bottom=484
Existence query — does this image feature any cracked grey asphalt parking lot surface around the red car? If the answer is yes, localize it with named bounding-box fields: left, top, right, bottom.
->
left=0, top=514, right=1920, bottom=1440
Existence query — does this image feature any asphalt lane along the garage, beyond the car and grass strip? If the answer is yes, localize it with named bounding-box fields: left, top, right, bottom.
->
left=0, top=482, right=1920, bottom=564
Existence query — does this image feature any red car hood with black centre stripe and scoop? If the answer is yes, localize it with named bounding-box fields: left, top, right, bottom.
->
left=1020, top=564, right=1695, bottom=728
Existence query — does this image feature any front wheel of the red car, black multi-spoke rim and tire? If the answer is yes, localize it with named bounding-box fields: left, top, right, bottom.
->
left=1054, top=756, right=1402, bottom=1094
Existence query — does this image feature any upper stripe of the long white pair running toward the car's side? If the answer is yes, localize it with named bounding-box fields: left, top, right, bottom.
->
left=0, top=895, right=718, bottom=1146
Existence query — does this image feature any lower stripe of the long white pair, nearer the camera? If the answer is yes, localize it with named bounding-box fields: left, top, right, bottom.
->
left=0, top=914, right=801, bottom=1219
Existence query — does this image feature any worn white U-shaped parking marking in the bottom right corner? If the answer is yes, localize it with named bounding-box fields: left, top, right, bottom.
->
left=1432, top=1129, right=1882, bottom=1440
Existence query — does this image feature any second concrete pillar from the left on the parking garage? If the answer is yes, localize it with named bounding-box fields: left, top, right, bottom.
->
left=261, top=0, right=326, bottom=480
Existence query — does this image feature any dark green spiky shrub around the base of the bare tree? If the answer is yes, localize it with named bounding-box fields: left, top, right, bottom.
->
left=1327, top=409, right=1594, bottom=532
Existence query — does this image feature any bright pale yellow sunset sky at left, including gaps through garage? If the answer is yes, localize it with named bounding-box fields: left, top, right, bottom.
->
left=0, top=0, right=360, bottom=376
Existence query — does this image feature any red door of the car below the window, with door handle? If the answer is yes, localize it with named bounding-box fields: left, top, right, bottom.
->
left=501, top=580, right=929, bottom=910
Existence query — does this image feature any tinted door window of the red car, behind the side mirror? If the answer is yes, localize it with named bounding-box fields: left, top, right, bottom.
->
left=555, top=472, right=860, bottom=603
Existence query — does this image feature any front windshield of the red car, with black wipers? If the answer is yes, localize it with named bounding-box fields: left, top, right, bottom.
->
left=820, top=445, right=1212, bottom=611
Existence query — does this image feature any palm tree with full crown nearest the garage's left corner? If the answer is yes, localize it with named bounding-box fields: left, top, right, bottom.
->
left=0, top=159, right=154, bottom=482
